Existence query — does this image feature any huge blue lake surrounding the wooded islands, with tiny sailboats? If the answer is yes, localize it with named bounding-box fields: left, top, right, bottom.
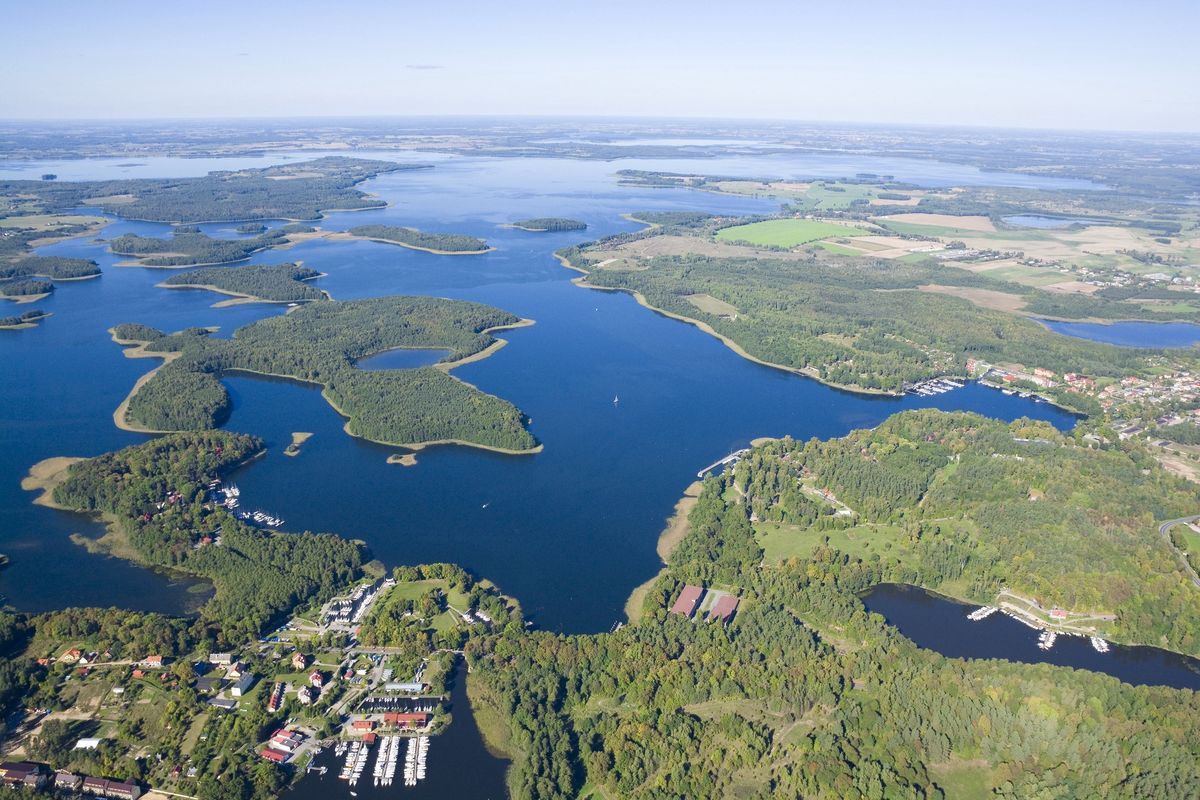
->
left=0, top=154, right=1073, bottom=632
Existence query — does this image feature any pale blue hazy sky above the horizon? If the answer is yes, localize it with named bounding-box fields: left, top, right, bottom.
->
left=0, top=0, right=1200, bottom=132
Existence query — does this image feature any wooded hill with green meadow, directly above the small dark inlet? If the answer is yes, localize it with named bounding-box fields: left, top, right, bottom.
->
left=733, top=411, right=1200, bottom=655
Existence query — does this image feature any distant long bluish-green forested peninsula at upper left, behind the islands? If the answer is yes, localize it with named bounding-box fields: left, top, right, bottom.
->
left=0, top=156, right=424, bottom=222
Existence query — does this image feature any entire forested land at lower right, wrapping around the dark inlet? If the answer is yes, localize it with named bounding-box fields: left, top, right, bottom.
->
left=467, top=411, right=1200, bottom=800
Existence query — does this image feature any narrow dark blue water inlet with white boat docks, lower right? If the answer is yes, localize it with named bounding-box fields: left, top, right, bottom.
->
left=863, top=583, right=1200, bottom=691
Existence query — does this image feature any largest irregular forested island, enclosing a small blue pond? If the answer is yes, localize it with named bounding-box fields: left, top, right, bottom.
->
left=114, top=296, right=535, bottom=450
